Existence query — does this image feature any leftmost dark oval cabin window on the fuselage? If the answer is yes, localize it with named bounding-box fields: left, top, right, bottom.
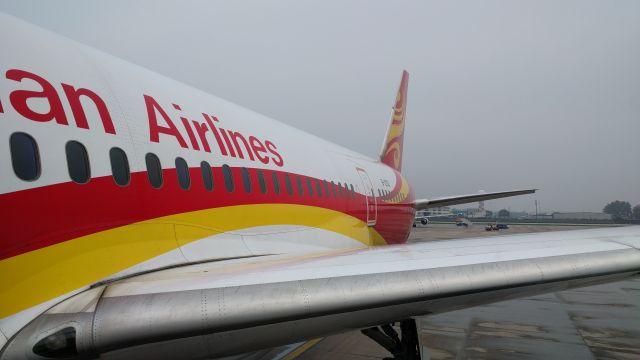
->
left=9, top=132, right=40, bottom=181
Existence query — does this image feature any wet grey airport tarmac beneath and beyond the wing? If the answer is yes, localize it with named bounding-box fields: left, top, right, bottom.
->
left=292, top=224, right=640, bottom=360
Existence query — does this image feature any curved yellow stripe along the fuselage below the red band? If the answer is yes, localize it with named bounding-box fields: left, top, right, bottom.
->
left=0, top=204, right=385, bottom=319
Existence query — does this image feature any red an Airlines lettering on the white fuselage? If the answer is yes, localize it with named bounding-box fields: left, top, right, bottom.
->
left=0, top=69, right=284, bottom=167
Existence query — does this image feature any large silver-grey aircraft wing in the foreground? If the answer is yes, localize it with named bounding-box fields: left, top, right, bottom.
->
left=6, top=226, right=640, bottom=359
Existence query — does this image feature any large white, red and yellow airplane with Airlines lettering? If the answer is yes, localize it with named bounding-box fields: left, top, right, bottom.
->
left=0, top=14, right=640, bottom=360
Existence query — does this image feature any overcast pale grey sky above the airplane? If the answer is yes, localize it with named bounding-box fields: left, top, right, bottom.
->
left=0, top=0, right=640, bottom=211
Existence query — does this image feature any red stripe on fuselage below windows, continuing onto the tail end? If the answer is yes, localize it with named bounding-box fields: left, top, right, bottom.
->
left=0, top=167, right=413, bottom=260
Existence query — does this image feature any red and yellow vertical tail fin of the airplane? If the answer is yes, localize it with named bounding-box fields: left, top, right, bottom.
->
left=380, top=70, right=409, bottom=171
